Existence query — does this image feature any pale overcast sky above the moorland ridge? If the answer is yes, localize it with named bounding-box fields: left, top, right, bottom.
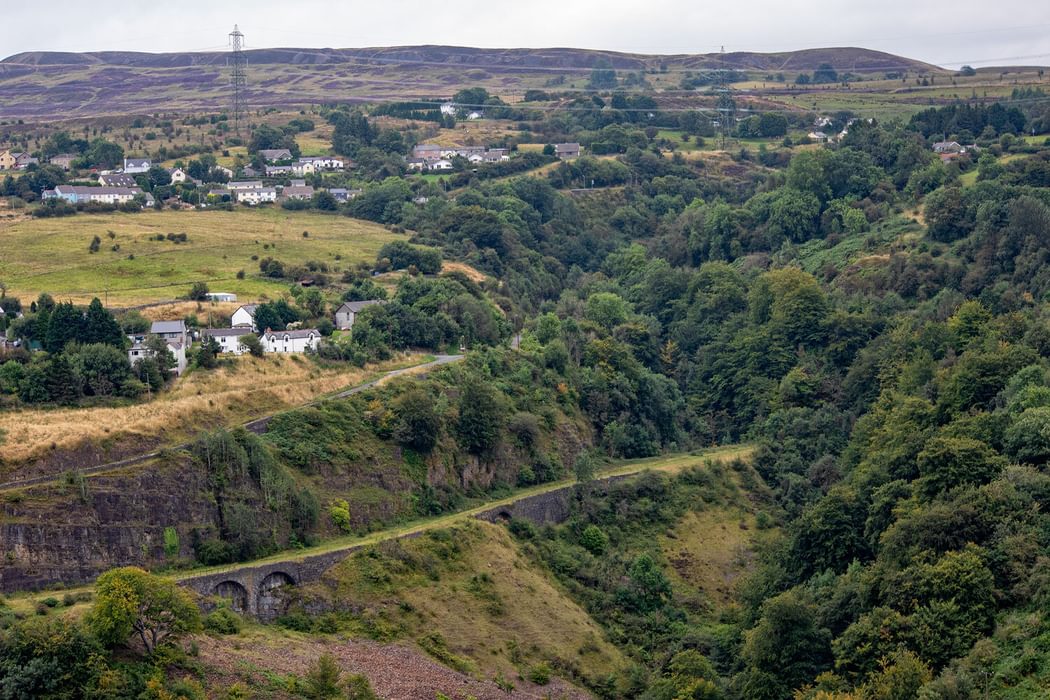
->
left=0, top=0, right=1050, bottom=67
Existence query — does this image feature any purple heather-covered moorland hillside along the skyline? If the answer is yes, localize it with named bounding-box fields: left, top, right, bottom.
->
left=0, top=46, right=942, bottom=119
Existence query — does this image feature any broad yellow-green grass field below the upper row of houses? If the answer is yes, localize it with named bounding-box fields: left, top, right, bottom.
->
left=0, top=208, right=397, bottom=306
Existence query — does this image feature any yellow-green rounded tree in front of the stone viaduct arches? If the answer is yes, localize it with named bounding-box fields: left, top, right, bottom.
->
left=88, top=567, right=201, bottom=654
